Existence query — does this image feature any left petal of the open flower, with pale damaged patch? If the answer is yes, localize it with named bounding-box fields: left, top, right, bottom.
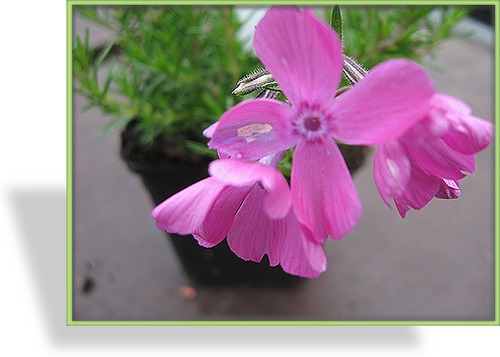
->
left=208, top=99, right=297, bottom=160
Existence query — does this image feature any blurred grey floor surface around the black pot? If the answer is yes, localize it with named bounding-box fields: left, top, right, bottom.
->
left=72, top=13, right=495, bottom=321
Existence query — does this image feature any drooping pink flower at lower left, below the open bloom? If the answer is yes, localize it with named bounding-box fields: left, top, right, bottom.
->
left=152, top=159, right=326, bottom=278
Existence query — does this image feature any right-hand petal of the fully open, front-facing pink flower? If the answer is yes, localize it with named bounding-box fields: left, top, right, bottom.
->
left=332, top=60, right=434, bottom=145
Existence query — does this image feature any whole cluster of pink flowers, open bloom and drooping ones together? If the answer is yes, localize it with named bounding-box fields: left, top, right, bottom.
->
left=153, top=8, right=493, bottom=277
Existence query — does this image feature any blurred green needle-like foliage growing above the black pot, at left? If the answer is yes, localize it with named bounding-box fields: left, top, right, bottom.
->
left=73, top=6, right=258, bottom=147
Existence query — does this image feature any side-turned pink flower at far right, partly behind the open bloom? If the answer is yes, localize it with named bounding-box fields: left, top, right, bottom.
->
left=374, top=94, right=493, bottom=218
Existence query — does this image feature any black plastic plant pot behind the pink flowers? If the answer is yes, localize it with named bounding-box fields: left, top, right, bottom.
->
left=122, top=122, right=366, bottom=287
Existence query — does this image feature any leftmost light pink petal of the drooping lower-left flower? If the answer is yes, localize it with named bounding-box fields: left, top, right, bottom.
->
left=152, top=177, right=226, bottom=235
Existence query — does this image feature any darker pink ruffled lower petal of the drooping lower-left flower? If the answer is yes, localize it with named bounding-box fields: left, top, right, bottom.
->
left=227, top=186, right=327, bottom=278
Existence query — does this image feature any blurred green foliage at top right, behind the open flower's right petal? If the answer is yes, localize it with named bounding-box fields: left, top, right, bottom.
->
left=341, top=5, right=469, bottom=69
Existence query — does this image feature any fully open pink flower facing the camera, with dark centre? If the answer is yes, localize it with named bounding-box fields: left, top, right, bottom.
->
left=209, top=8, right=434, bottom=243
